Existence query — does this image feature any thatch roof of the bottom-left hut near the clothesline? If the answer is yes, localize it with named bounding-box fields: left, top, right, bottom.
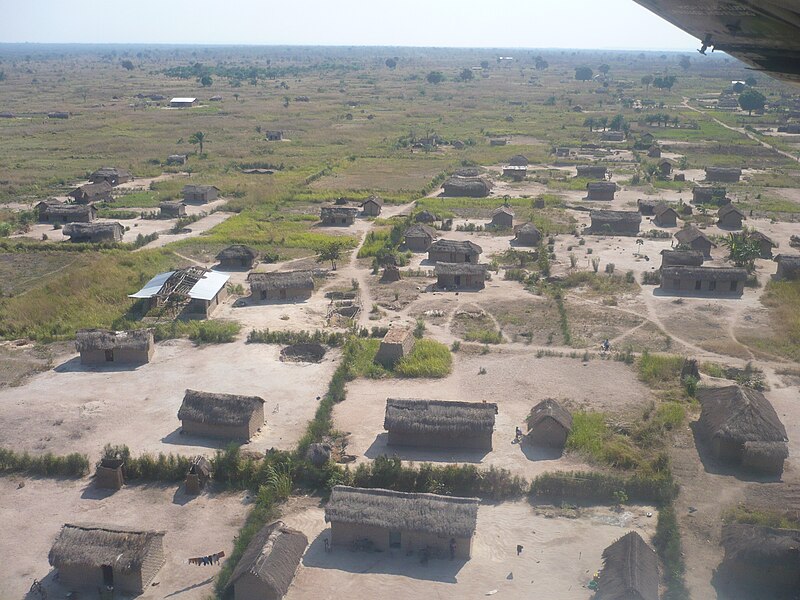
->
left=48, top=523, right=164, bottom=571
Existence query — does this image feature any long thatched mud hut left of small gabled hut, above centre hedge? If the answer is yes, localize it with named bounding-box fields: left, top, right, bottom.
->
left=383, top=398, right=497, bottom=452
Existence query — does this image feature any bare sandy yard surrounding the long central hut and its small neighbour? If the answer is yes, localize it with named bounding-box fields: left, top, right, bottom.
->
left=334, top=348, right=652, bottom=479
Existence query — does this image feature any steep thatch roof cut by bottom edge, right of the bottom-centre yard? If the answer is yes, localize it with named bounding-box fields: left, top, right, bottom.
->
left=597, top=531, right=658, bottom=600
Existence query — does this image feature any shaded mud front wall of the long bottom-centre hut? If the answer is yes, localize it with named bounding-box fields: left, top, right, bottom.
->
left=331, top=521, right=472, bottom=559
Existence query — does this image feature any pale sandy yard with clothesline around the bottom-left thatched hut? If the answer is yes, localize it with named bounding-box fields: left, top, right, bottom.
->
left=0, top=477, right=250, bottom=600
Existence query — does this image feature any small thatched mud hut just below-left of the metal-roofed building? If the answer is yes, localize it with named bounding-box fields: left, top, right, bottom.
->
left=75, top=329, right=155, bottom=365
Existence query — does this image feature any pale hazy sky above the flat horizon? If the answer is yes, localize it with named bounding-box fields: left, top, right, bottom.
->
left=0, top=0, right=698, bottom=50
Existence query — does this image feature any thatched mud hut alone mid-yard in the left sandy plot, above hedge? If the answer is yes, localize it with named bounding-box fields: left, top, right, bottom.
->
left=178, top=390, right=264, bottom=441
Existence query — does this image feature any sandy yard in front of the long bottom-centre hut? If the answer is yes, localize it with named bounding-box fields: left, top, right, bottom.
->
left=283, top=502, right=655, bottom=600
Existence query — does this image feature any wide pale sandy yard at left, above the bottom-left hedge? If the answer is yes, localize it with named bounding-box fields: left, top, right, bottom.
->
left=0, top=340, right=338, bottom=458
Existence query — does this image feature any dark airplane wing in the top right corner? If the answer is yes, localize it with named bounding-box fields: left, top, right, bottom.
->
left=635, top=0, right=800, bottom=84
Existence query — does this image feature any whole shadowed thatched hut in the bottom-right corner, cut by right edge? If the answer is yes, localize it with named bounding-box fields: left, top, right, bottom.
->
left=717, top=523, right=800, bottom=598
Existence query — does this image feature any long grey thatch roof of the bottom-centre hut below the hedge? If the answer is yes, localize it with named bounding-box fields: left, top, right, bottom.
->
left=325, top=485, right=479, bottom=538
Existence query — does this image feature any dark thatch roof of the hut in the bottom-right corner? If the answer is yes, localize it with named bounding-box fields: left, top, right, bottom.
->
left=722, top=523, right=800, bottom=570
